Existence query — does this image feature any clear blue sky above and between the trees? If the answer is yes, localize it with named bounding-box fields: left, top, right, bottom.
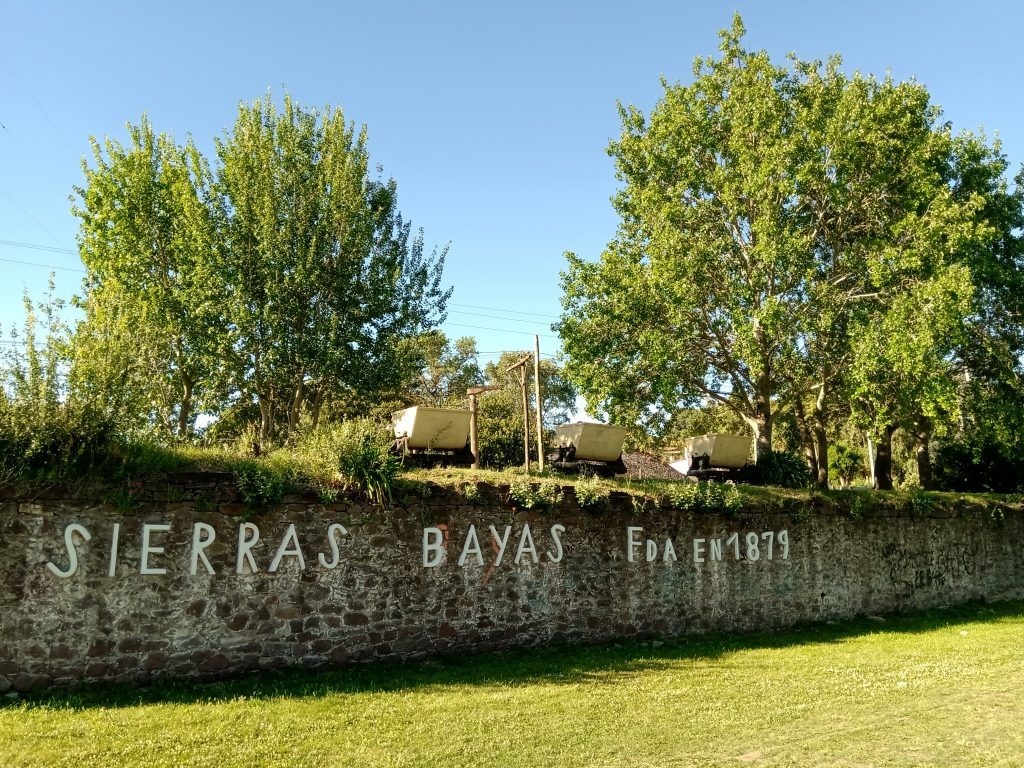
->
left=0, top=0, right=1024, bottom=372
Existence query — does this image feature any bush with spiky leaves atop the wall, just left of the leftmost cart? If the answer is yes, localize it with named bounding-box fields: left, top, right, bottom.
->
left=295, top=419, right=400, bottom=503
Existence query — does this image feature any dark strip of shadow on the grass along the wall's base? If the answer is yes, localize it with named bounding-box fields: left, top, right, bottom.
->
left=9, top=600, right=1024, bottom=710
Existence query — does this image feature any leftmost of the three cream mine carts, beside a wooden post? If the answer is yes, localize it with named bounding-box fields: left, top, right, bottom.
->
left=391, top=406, right=473, bottom=467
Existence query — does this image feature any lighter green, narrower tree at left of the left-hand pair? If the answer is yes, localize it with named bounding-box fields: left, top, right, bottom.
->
left=73, top=117, right=224, bottom=437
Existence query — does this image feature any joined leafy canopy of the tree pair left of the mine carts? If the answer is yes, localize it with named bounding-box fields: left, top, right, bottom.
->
left=76, top=95, right=451, bottom=440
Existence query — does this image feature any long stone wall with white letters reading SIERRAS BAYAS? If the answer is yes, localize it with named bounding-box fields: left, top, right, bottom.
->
left=0, top=475, right=1024, bottom=691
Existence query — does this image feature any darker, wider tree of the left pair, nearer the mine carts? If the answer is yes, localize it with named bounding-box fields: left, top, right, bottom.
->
left=215, top=96, right=451, bottom=440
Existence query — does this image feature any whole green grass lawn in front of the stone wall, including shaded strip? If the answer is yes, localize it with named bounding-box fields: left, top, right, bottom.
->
left=0, top=602, right=1024, bottom=768
